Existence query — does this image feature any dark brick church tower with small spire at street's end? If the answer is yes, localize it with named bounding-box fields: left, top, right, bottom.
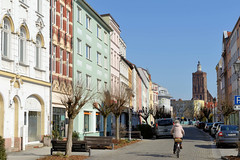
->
left=192, top=61, right=208, bottom=102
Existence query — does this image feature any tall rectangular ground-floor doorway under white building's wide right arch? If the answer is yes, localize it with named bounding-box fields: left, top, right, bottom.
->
left=28, top=111, right=41, bottom=142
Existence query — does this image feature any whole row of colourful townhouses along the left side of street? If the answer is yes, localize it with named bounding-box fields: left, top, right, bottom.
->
left=0, top=0, right=170, bottom=151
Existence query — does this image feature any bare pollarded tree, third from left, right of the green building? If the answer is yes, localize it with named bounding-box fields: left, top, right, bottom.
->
left=111, top=87, right=132, bottom=140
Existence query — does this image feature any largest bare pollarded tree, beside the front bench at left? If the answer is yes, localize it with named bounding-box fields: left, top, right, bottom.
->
left=60, top=82, right=95, bottom=156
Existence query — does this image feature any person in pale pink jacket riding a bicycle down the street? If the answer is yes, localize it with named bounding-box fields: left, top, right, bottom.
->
left=171, top=120, right=185, bottom=154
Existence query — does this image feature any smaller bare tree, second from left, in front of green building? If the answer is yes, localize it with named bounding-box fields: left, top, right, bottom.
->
left=93, top=90, right=114, bottom=137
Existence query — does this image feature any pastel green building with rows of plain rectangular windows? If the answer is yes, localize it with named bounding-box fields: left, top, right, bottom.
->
left=73, top=0, right=112, bottom=139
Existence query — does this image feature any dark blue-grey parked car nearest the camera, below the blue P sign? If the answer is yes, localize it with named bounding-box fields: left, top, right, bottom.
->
left=216, top=125, right=239, bottom=148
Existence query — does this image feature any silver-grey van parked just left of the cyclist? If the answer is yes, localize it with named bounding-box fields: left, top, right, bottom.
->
left=155, top=118, right=173, bottom=137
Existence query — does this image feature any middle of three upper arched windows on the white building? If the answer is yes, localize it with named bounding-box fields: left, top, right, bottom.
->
left=18, top=26, right=26, bottom=63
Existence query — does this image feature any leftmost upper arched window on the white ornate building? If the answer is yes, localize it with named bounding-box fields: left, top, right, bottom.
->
left=1, top=18, right=11, bottom=58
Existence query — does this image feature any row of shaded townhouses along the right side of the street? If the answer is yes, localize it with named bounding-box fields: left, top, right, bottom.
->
left=216, top=17, right=240, bottom=125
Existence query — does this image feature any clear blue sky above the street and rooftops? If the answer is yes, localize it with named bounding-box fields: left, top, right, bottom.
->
left=86, top=0, right=240, bottom=100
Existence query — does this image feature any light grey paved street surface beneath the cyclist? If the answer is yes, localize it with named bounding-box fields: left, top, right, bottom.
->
left=8, top=126, right=237, bottom=160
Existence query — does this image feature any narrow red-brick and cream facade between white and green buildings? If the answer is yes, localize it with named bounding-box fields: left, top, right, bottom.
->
left=50, top=0, right=73, bottom=137
